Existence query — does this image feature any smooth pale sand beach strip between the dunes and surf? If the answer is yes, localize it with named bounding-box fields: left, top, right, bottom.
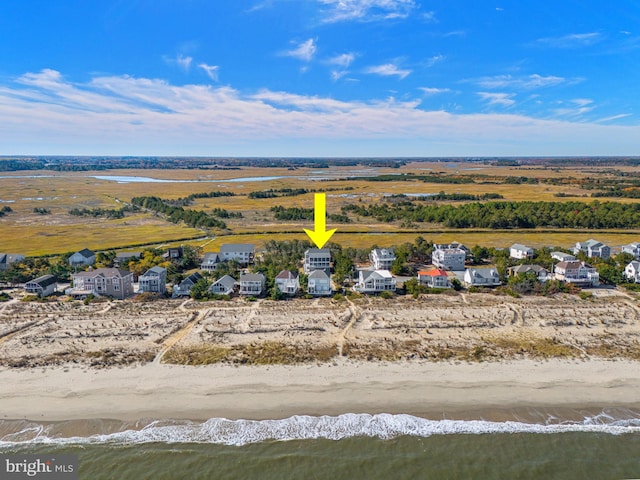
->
left=0, top=359, right=640, bottom=423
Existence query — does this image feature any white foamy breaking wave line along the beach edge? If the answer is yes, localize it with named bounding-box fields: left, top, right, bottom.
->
left=0, top=412, right=640, bottom=448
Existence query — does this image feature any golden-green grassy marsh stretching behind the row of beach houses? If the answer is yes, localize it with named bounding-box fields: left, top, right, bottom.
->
left=0, top=162, right=640, bottom=255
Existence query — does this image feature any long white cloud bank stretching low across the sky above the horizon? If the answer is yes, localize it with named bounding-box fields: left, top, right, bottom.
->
left=0, top=70, right=640, bottom=156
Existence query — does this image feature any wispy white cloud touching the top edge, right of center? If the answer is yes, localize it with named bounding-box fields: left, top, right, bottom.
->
left=318, top=0, right=417, bottom=23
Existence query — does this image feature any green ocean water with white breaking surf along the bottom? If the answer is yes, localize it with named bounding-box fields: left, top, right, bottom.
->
left=0, top=411, right=640, bottom=480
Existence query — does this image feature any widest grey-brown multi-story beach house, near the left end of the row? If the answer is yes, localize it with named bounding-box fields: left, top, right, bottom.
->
left=65, top=268, right=133, bottom=300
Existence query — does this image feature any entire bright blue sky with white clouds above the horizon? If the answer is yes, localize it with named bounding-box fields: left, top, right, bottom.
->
left=0, top=0, right=640, bottom=156
